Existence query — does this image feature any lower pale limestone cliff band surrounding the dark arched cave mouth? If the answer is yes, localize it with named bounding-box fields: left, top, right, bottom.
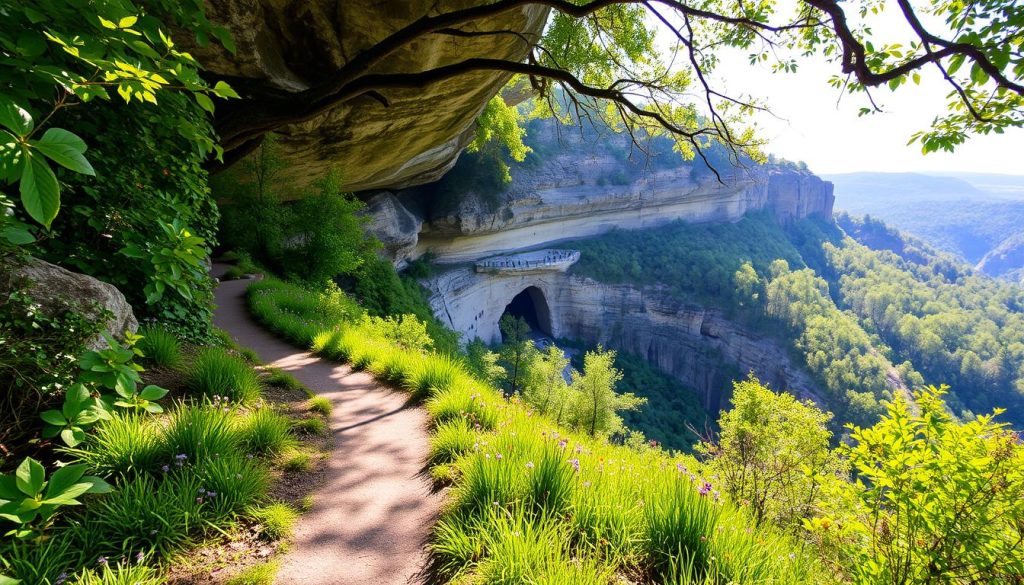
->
left=427, top=268, right=822, bottom=412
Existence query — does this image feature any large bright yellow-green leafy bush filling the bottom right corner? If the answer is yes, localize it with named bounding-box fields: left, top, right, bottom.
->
left=805, top=386, right=1024, bottom=585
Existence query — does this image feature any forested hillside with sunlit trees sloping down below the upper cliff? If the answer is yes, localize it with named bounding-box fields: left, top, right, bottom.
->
left=573, top=216, right=1024, bottom=424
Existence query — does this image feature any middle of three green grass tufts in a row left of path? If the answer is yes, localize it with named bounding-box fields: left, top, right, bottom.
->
left=164, top=405, right=242, bottom=466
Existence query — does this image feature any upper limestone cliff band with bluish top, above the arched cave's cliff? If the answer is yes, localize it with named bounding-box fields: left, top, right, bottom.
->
left=416, top=161, right=835, bottom=262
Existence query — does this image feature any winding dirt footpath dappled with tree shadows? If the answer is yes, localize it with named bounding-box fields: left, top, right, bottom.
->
left=213, top=265, right=441, bottom=585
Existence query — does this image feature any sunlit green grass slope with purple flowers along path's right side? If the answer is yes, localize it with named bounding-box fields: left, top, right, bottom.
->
left=249, top=280, right=829, bottom=585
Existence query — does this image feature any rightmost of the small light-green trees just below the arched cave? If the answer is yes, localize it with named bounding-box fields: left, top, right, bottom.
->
left=570, top=346, right=647, bottom=436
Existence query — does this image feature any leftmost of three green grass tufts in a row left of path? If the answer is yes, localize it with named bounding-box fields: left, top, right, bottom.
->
left=67, top=412, right=171, bottom=476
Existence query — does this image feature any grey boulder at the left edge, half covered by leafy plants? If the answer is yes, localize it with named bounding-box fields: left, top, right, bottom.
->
left=0, top=258, right=138, bottom=349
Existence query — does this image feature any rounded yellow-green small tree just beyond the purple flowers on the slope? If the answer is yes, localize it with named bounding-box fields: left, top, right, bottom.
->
left=697, top=375, right=844, bottom=529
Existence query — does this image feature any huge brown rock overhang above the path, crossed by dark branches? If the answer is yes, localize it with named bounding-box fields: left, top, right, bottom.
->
left=189, top=0, right=548, bottom=191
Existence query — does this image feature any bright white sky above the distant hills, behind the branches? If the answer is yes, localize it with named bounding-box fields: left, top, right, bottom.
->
left=651, top=0, right=1024, bottom=174
